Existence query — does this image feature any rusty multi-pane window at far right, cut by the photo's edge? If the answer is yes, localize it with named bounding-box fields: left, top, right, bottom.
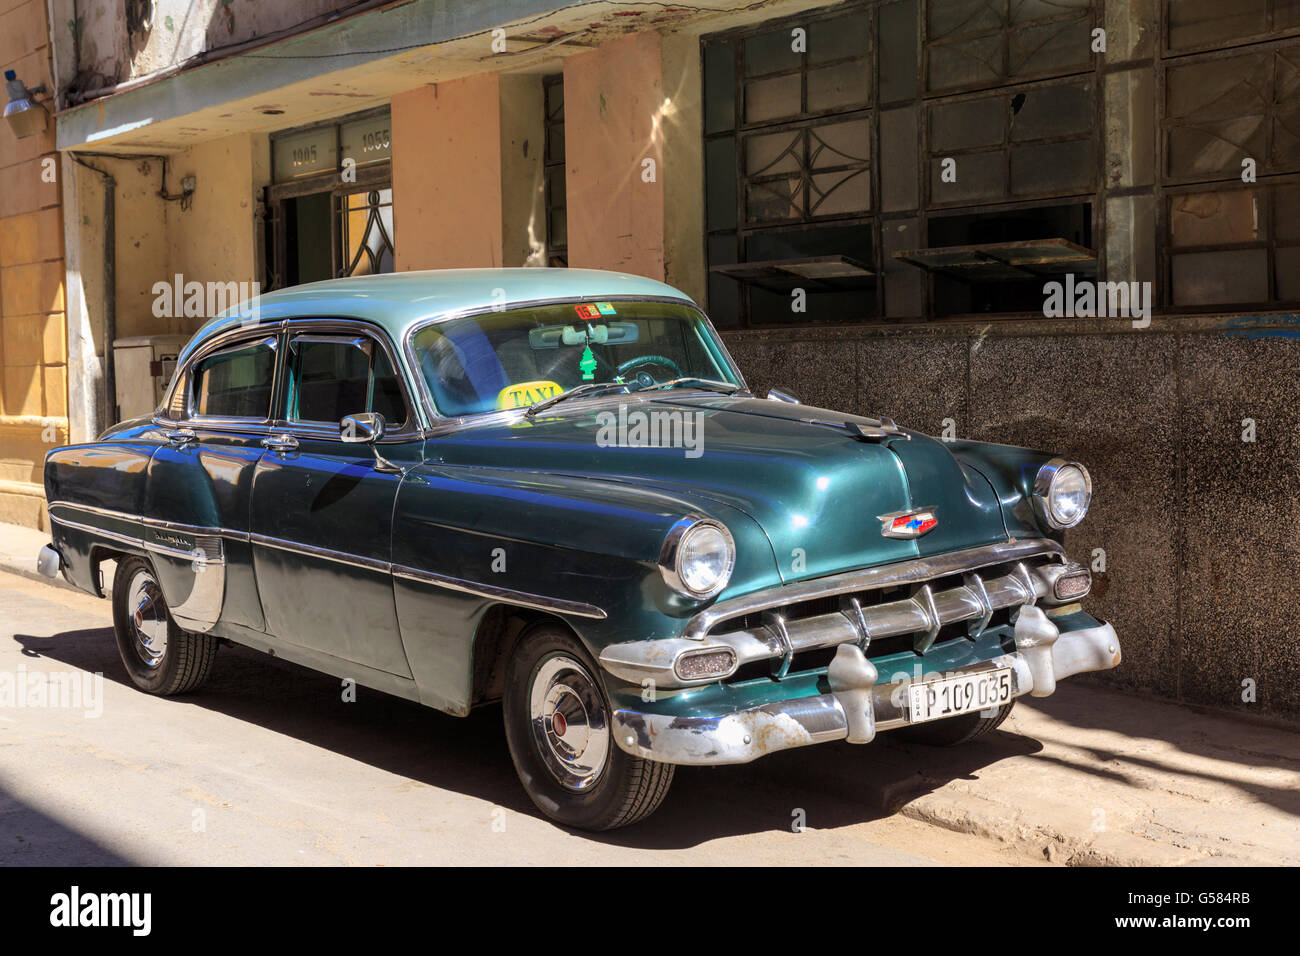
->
left=1154, top=22, right=1300, bottom=310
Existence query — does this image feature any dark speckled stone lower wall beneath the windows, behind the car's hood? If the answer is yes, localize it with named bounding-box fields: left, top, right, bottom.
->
left=727, top=316, right=1300, bottom=730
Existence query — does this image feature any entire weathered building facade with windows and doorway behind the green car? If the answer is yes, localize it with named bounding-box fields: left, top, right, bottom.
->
left=0, top=0, right=1300, bottom=715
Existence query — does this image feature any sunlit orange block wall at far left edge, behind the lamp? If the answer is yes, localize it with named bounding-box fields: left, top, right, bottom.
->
left=0, top=0, right=68, bottom=527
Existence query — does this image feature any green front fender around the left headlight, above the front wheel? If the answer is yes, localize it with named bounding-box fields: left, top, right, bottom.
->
left=393, top=464, right=780, bottom=642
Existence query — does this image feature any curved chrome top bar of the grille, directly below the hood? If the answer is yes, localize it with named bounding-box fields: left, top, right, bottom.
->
left=683, top=538, right=1065, bottom=641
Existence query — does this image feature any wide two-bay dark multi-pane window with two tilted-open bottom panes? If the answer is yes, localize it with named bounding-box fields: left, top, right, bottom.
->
left=702, top=0, right=1101, bottom=326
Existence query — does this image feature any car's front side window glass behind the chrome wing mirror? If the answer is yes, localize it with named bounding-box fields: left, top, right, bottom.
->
left=290, top=334, right=407, bottom=427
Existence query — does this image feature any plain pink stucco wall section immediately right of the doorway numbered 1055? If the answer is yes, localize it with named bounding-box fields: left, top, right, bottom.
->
left=393, top=73, right=502, bottom=272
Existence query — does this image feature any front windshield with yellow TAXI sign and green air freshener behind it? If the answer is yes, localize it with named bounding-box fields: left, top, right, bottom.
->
left=412, top=299, right=742, bottom=416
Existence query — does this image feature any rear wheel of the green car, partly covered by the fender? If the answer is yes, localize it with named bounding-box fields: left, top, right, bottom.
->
left=113, top=557, right=218, bottom=696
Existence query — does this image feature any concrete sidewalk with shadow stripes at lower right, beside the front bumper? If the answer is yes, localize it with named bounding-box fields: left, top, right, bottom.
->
left=896, top=683, right=1300, bottom=866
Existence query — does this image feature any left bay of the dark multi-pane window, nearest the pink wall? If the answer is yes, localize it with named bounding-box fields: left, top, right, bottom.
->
left=702, top=8, right=878, bottom=326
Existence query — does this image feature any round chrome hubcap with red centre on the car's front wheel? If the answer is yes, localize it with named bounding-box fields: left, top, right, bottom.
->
left=529, top=654, right=610, bottom=790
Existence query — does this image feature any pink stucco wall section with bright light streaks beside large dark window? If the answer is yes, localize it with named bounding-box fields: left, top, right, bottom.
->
left=564, top=31, right=664, bottom=280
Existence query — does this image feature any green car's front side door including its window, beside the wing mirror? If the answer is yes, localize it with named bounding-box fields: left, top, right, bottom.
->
left=252, top=321, right=423, bottom=676
